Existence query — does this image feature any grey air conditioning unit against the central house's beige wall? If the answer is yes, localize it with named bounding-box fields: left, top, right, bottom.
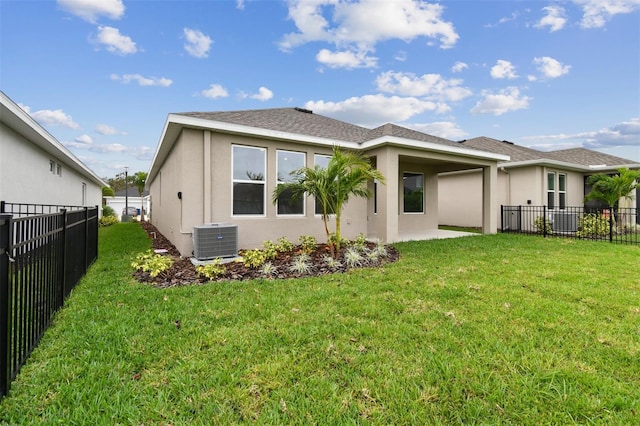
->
left=193, top=223, right=238, bottom=260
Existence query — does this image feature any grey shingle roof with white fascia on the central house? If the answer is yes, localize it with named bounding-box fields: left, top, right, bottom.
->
left=149, top=108, right=508, bottom=180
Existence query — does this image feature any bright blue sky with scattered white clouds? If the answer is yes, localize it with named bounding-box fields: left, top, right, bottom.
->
left=0, top=0, right=640, bottom=177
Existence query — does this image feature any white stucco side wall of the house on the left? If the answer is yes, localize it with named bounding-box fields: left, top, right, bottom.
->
left=0, top=124, right=102, bottom=210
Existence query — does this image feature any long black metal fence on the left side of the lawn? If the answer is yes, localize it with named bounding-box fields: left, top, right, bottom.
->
left=0, top=203, right=98, bottom=397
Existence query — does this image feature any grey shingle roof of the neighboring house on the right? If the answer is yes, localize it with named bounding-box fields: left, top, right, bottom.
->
left=461, top=136, right=640, bottom=171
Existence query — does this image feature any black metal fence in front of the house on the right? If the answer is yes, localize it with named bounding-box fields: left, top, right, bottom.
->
left=500, top=205, right=640, bottom=245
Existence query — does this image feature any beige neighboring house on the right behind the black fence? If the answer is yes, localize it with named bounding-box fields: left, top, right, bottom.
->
left=439, top=137, right=640, bottom=227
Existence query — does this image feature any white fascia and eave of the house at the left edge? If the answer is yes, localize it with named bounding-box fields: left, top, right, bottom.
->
left=0, top=91, right=109, bottom=187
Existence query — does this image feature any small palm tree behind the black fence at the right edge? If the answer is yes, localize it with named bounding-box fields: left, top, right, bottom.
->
left=584, top=168, right=640, bottom=226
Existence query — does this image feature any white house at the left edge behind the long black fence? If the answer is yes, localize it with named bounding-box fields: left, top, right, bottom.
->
left=0, top=92, right=107, bottom=212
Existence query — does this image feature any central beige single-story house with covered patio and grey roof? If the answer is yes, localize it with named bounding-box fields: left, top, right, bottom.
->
left=147, top=108, right=508, bottom=255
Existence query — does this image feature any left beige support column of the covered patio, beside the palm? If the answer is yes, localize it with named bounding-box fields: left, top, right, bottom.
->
left=377, top=148, right=400, bottom=243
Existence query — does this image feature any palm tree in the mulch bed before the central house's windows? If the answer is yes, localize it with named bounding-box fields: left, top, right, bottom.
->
left=273, top=146, right=385, bottom=255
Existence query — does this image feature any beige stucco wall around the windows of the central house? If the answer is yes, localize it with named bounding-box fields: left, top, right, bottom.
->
left=150, top=129, right=367, bottom=256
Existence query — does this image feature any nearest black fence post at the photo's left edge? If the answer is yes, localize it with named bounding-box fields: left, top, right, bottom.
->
left=0, top=212, right=12, bottom=397
